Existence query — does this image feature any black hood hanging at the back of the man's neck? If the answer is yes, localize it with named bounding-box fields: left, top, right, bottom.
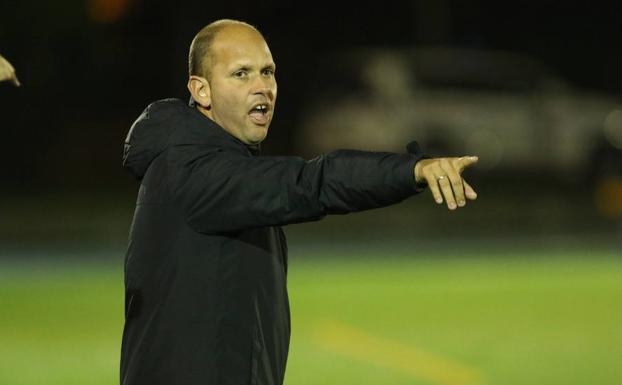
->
left=123, top=99, right=259, bottom=180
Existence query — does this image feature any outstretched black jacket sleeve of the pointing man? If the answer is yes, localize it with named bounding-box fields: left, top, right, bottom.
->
left=169, top=146, right=422, bottom=233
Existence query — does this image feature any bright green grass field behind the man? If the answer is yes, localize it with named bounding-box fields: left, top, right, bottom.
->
left=0, top=251, right=622, bottom=385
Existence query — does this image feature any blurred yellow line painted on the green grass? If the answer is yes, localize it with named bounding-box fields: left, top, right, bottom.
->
left=314, top=321, right=484, bottom=385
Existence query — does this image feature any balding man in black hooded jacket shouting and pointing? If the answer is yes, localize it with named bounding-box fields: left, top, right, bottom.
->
left=121, top=20, right=477, bottom=385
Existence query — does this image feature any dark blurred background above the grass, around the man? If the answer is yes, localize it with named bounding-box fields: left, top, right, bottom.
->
left=0, top=0, right=622, bottom=250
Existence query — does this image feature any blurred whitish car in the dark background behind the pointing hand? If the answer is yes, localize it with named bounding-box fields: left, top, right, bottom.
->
left=296, top=48, right=622, bottom=179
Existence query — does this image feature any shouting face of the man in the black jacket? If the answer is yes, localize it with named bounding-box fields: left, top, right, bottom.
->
left=208, top=26, right=277, bottom=144
